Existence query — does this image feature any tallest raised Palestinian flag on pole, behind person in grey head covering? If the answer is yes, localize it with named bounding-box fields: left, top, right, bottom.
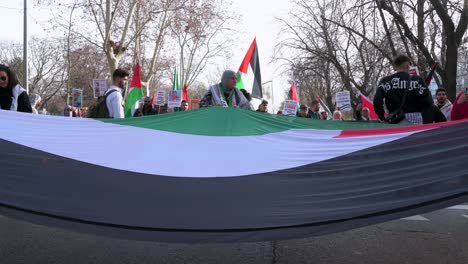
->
left=236, top=38, right=263, bottom=99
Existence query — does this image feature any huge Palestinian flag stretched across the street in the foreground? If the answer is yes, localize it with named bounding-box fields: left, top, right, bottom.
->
left=0, top=107, right=468, bottom=243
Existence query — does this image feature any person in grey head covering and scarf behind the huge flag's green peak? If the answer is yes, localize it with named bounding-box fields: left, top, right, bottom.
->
left=200, top=70, right=253, bottom=110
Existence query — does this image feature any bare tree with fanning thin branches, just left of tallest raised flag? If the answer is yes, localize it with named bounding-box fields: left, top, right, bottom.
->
left=171, top=0, right=237, bottom=86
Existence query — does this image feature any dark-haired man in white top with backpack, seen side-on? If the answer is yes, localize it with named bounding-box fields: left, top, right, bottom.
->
left=105, top=69, right=129, bottom=118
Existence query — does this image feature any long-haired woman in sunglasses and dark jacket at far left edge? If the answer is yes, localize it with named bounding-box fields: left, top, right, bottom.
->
left=0, top=64, right=32, bottom=113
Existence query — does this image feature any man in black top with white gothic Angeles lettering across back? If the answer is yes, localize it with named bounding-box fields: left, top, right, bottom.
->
left=374, top=55, right=433, bottom=124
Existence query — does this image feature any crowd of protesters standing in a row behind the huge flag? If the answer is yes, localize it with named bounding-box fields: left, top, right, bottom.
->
left=0, top=58, right=468, bottom=124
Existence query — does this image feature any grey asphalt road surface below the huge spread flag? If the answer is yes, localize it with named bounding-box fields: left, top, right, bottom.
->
left=0, top=204, right=468, bottom=264
